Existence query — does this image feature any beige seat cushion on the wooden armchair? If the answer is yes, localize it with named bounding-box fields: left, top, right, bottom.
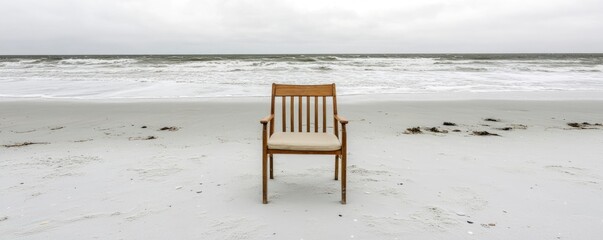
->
left=268, top=132, right=341, bottom=151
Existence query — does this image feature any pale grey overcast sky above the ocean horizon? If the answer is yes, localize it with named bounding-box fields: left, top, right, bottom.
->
left=0, top=0, right=603, bottom=55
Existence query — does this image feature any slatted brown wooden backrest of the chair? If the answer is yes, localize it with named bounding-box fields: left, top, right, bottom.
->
left=270, top=83, right=339, bottom=135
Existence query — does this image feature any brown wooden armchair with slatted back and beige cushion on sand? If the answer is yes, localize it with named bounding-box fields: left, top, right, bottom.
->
left=260, top=84, right=348, bottom=204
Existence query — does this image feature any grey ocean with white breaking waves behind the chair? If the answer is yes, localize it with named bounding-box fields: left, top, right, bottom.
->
left=0, top=54, right=603, bottom=99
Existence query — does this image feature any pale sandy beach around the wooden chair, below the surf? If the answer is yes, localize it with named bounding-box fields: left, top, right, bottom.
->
left=0, top=98, right=603, bottom=239
